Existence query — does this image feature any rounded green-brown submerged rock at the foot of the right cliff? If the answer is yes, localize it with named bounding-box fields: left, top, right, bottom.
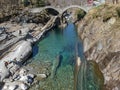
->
left=75, top=61, right=104, bottom=90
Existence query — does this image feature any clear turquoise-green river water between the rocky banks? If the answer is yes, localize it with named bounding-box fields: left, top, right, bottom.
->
left=28, top=24, right=102, bottom=90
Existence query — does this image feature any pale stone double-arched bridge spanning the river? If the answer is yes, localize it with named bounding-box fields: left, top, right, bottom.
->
left=29, top=5, right=92, bottom=14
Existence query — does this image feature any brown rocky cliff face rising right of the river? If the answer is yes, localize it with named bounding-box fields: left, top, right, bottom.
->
left=78, top=5, right=120, bottom=90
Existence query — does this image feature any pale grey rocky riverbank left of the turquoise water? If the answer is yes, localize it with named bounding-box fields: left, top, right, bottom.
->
left=0, top=7, right=57, bottom=90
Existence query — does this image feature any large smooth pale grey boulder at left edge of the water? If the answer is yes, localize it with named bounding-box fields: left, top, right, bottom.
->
left=1, top=40, right=32, bottom=62
